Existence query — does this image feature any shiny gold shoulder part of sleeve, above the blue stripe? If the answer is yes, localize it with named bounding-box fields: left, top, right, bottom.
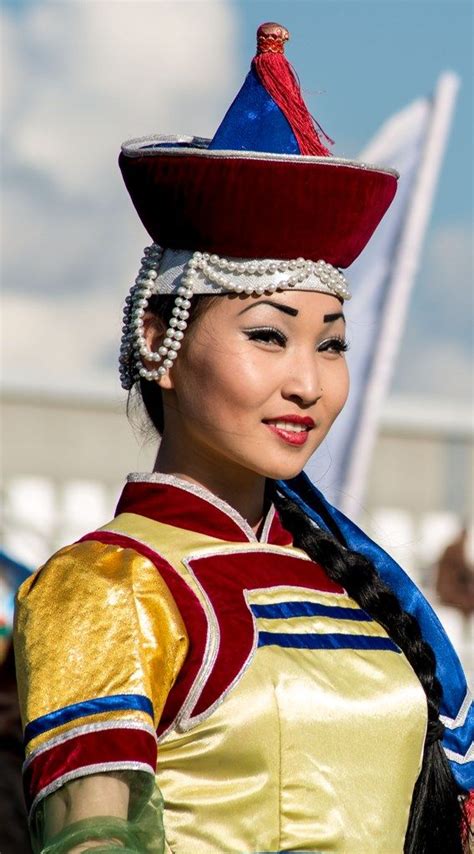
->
left=14, top=539, right=189, bottom=721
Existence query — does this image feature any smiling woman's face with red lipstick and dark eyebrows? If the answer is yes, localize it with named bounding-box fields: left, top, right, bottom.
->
left=155, top=291, right=348, bottom=479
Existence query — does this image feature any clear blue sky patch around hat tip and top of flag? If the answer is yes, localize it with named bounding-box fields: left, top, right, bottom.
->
left=239, top=0, right=474, bottom=225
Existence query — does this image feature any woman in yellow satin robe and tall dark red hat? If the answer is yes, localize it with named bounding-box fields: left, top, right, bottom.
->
left=12, top=24, right=469, bottom=854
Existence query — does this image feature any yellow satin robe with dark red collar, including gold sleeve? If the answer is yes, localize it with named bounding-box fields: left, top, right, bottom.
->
left=16, top=475, right=426, bottom=854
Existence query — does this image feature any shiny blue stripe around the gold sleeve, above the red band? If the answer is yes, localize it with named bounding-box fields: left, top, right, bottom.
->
left=25, top=694, right=153, bottom=744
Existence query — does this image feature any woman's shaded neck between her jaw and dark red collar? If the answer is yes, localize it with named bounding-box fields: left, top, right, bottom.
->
left=154, top=434, right=267, bottom=531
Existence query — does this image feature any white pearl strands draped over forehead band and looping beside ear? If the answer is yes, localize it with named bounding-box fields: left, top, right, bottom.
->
left=119, top=243, right=351, bottom=391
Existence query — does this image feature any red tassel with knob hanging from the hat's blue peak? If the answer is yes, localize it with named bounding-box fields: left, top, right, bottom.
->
left=252, top=24, right=332, bottom=157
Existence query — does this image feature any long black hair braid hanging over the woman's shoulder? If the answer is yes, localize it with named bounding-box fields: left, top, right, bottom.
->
left=274, top=493, right=468, bottom=854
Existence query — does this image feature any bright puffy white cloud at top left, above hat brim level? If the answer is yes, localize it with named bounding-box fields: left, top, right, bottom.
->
left=4, top=0, right=241, bottom=199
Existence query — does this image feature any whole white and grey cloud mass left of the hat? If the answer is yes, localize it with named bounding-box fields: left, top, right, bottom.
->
left=1, top=0, right=240, bottom=387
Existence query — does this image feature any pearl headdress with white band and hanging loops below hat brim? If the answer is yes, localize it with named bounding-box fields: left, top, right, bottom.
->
left=120, top=243, right=351, bottom=390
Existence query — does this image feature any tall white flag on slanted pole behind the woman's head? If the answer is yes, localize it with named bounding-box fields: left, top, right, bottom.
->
left=306, top=73, right=459, bottom=518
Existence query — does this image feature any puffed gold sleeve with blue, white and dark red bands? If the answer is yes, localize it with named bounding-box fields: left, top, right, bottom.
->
left=14, top=540, right=188, bottom=828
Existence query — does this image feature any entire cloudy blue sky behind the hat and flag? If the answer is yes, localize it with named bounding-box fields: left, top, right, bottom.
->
left=0, top=0, right=474, bottom=403
